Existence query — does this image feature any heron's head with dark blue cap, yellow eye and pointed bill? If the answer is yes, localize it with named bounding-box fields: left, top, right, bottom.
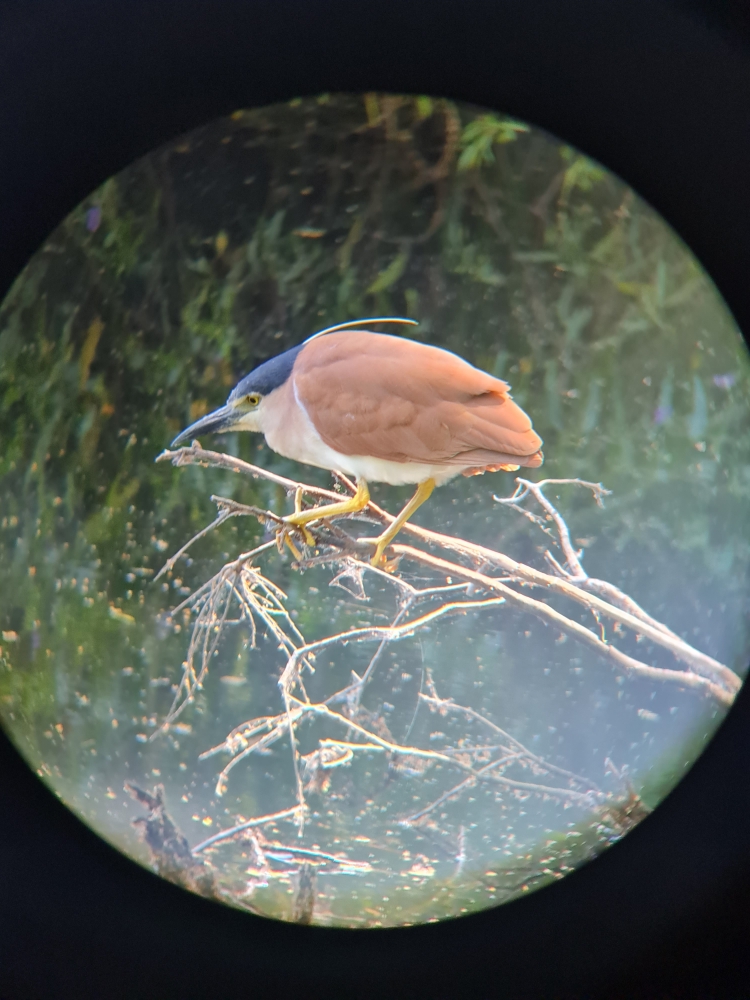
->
left=171, top=344, right=303, bottom=448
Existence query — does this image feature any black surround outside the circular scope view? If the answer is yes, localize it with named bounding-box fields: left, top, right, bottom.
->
left=0, top=0, right=750, bottom=1000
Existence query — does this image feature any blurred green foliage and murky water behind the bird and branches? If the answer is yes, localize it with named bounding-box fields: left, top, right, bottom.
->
left=0, top=94, right=750, bottom=924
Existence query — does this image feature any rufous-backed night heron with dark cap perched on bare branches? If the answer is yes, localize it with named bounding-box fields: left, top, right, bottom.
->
left=171, top=317, right=544, bottom=567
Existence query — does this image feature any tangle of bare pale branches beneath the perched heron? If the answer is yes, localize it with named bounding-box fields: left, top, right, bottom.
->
left=152, top=444, right=741, bottom=922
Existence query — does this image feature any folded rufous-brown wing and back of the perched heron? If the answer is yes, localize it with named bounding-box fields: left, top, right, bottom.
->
left=292, top=331, right=542, bottom=465
